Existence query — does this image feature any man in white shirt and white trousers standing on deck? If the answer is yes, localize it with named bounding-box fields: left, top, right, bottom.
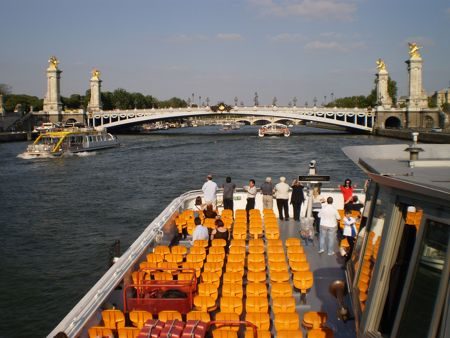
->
left=319, top=197, right=341, bottom=256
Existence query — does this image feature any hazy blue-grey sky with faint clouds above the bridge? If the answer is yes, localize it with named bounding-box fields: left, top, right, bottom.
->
left=0, top=0, right=450, bottom=106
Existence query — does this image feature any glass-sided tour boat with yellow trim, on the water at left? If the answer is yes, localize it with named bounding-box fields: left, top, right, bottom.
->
left=22, top=127, right=119, bottom=157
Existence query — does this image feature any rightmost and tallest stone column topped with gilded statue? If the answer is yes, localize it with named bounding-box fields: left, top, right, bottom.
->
left=405, top=43, right=428, bottom=111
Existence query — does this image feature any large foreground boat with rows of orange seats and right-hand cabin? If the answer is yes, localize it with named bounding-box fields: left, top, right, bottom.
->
left=48, top=140, right=450, bottom=338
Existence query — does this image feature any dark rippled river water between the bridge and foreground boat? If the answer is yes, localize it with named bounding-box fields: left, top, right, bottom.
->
left=0, top=126, right=404, bottom=337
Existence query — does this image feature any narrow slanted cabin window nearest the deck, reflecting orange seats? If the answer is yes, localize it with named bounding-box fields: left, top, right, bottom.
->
left=355, top=185, right=390, bottom=312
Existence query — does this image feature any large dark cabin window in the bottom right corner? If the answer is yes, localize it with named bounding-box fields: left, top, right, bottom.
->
left=396, top=220, right=450, bottom=338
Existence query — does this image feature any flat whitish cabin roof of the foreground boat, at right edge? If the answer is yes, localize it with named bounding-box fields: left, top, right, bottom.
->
left=342, top=144, right=450, bottom=196
